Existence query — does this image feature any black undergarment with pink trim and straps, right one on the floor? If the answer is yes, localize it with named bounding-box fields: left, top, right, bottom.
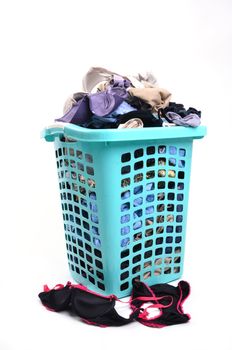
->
left=131, top=281, right=190, bottom=327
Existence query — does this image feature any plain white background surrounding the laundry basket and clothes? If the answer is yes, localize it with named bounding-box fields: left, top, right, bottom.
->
left=0, top=0, right=232, bottom=350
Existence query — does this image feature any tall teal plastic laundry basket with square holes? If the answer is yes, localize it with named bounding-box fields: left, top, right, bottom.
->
left=42, top=124, right=206, bottom=297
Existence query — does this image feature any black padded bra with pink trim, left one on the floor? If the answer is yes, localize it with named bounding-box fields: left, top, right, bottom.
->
left=39, top=283, right=140, bottom=326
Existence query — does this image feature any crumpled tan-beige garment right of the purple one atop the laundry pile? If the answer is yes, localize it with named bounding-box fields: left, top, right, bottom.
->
left=128, top=87, right=172, bottom=112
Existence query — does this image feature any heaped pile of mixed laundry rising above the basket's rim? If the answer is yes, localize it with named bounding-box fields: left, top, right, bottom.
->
left=56, top=67, right=201, bottom=129
